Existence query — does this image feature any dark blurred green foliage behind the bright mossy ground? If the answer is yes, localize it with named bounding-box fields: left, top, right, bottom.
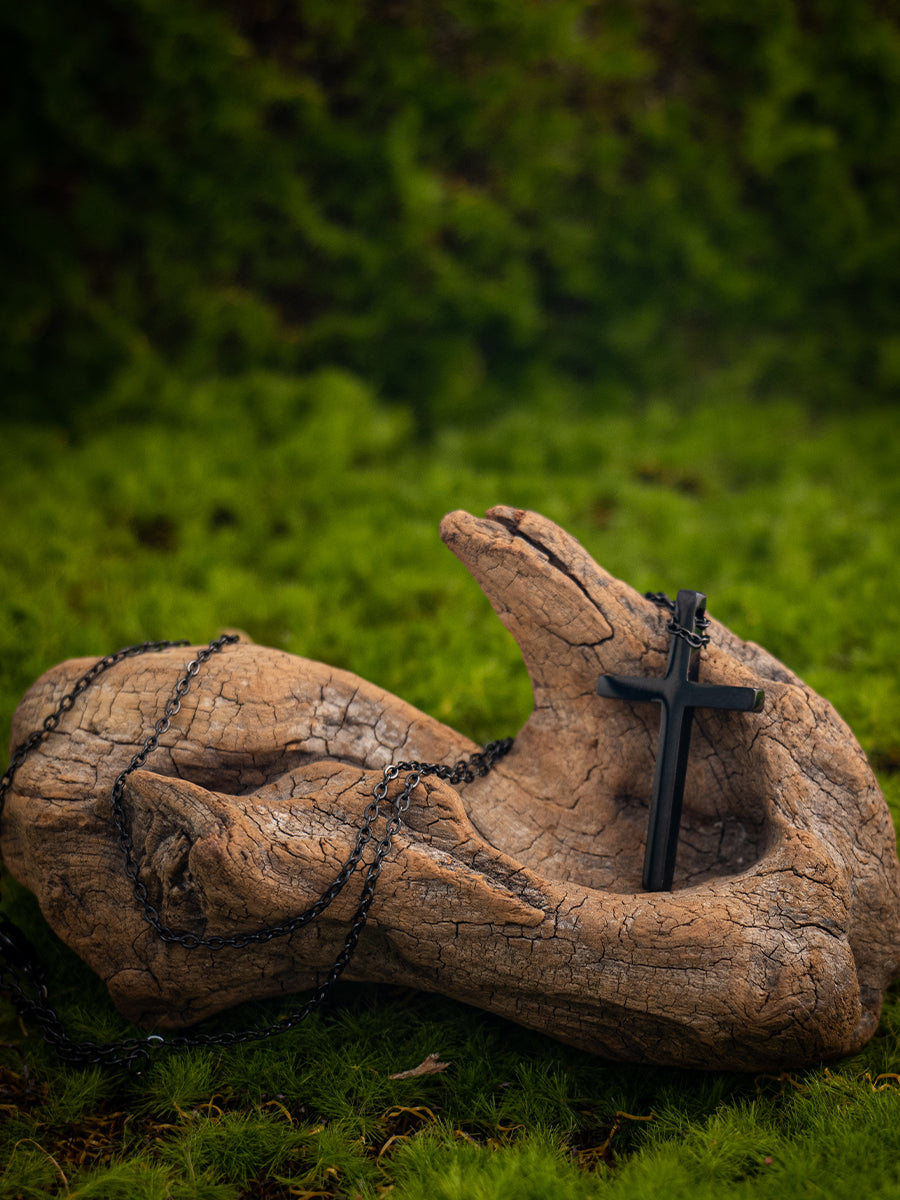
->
left=0, top=0, right=900, bottom=430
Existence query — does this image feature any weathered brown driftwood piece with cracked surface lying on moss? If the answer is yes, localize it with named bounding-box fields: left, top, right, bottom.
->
left=2, top=508, right=900, bottom=1070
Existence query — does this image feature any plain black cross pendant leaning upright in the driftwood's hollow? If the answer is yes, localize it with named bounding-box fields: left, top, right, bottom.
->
left=596, top=589, right=766, bottom=892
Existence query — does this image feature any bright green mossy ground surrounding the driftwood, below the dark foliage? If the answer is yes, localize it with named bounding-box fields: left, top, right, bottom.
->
left=0, top=386, right=900, bottom=1200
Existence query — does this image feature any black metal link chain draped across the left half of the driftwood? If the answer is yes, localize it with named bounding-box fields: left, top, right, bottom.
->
left=0, top=634, right=512, bottom=1068
